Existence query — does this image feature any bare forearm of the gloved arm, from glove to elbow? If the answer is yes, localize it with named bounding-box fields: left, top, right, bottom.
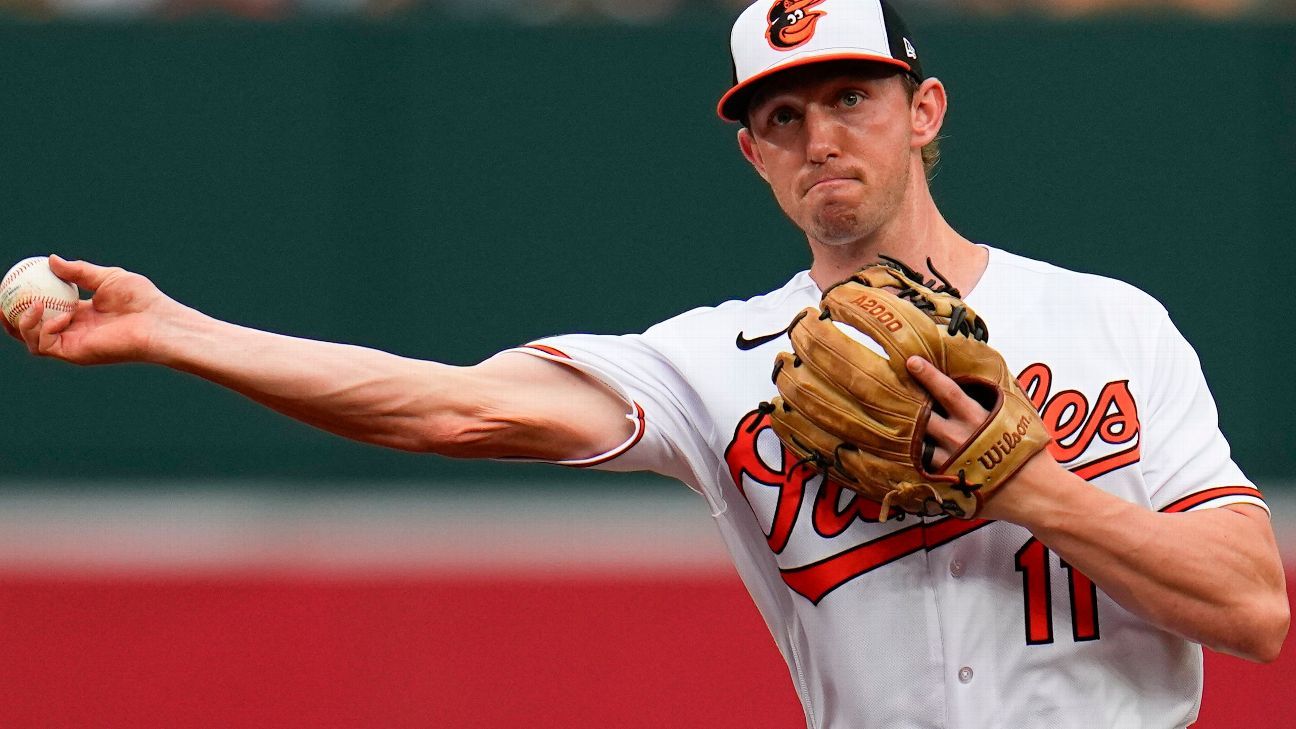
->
left=991, top=459, right=1288, bottom=660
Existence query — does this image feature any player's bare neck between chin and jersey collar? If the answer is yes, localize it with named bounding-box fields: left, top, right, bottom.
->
left=809, top=178, right=989, bottom=296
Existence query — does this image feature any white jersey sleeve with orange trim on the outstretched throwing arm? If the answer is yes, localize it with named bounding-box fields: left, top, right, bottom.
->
left=508, top=335, right=709, bottom=492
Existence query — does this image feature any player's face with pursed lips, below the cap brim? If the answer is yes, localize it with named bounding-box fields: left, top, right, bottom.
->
left=740, top=65, right=921, bottom=245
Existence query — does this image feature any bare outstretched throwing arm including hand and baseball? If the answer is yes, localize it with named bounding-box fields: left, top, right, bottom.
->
left=4, top=256, right=632, bottom=460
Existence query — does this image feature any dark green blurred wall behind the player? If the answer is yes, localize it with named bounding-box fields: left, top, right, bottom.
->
left=0, top=16, right=1296, bottom=480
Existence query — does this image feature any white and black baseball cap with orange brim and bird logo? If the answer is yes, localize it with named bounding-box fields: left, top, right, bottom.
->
left=717, top=0, right=924, bottom=122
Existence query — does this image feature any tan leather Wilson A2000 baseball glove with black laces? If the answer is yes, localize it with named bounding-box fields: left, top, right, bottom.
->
left=762, top=257, right=1048, bottom=520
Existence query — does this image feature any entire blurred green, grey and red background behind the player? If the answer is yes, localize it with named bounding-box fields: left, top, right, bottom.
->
left=0, top=0, right=1296, bottom=728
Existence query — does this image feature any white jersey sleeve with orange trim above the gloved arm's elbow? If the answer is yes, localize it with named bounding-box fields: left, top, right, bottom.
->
left=1140, top=310, right=1269, bottom=512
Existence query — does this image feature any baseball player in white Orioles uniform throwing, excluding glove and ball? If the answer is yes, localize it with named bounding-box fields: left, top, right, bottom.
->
left=6, top=0, right=1288, bottom=729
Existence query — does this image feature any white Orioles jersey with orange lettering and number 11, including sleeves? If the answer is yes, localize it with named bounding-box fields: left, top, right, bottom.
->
left=505, top=248, right=1264, bottom=729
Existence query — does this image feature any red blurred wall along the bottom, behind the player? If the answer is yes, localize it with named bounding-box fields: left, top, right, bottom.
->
left=0, top=572, right=1296, bottom=729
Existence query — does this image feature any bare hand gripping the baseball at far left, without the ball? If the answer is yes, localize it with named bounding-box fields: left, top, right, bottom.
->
left=3, top=256, right=180, bottom=365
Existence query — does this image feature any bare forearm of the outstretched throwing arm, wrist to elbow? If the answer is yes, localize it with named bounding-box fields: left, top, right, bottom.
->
left=145, top=300, right=467, bottom=451
